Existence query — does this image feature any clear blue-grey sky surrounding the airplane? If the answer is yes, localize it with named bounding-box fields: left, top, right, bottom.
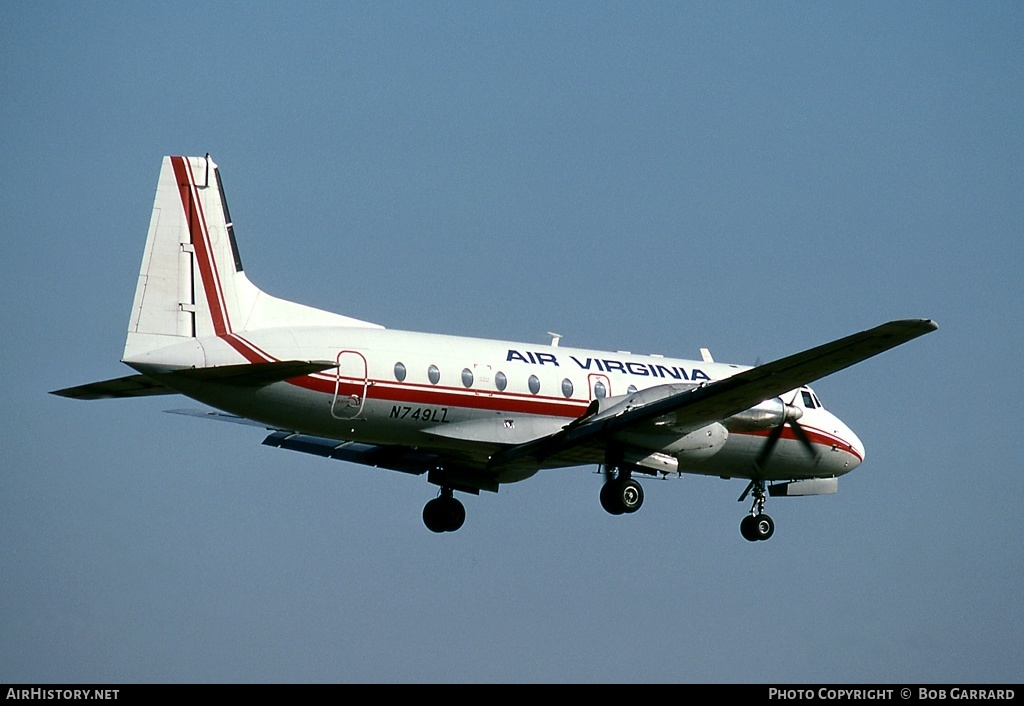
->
left=0, top=2, right=1024, bottom=682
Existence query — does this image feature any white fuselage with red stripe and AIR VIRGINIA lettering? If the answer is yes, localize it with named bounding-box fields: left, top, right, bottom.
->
left=131, top=327, right=864, bottom=480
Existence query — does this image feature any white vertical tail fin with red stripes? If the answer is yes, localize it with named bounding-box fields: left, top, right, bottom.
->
left=123, top=156, right=377, bottom=362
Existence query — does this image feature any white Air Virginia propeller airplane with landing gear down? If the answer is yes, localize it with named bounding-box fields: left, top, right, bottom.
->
left=53, top=154, right=938, bottom=542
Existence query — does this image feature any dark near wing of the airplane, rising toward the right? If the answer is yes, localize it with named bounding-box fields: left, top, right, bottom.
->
left=488, top=319, right=938, bottom=468
